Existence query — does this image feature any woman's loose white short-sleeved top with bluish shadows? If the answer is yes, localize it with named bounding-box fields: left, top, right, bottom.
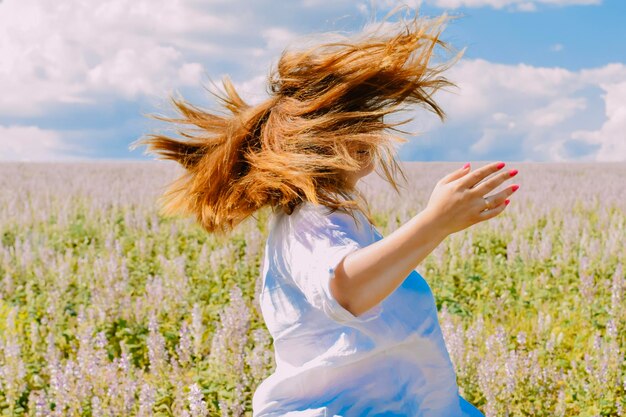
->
left=252, top=202, right=484, bottom=417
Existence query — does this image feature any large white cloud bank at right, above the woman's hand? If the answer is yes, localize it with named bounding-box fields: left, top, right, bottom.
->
left=400, top=59, right=626, bottom=161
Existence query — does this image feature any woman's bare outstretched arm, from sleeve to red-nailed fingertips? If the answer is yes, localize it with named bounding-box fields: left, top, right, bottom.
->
left=330, top=163, right=517, bottom=316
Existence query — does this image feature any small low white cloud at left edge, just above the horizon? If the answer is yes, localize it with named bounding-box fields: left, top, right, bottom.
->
left=0, top=125, right=80, bottom=162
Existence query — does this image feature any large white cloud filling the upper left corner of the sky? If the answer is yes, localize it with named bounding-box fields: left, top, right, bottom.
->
left=0, top=0, right=332, bottom=116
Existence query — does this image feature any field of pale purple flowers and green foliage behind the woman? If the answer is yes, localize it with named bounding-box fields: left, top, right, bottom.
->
left=0, top=162, right=626, bottom=417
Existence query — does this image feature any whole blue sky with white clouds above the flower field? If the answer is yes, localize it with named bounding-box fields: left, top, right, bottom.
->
left=0, top=0, right=626, bottom=162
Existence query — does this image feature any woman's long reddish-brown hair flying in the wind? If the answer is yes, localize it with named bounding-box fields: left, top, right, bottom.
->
left=134, top=8, right=464, bottom=235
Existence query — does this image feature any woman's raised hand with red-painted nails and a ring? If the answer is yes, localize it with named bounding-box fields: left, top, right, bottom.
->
left=425, top=162, right=519, bottom=234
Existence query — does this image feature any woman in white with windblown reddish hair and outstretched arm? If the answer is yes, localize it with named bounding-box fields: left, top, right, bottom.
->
left=133, top=7, right=517, bottom=417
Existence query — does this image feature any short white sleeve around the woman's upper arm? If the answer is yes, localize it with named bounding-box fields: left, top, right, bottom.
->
left=289, top=208, right=382, bottom=325
